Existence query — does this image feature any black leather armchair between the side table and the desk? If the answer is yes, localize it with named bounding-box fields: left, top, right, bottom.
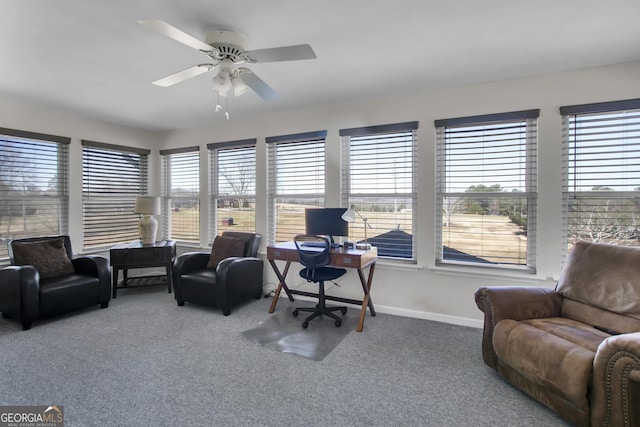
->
left=173, top=231, right=264, bottom=316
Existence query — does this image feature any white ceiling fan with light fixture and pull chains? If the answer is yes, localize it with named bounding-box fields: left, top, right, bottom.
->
left=138, top=19, right=316, bottom=103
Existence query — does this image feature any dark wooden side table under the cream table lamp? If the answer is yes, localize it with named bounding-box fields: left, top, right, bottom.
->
left=109, top=240, right=176, bottom=298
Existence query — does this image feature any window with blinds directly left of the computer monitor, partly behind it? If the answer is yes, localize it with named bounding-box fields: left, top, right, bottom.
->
left=267, top=131, right=327, bottom=243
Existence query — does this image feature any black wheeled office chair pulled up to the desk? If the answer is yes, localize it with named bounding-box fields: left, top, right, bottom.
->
left=292, top=234, right=347, bottom=329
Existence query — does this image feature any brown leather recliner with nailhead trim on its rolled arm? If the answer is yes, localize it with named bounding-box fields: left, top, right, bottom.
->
left=475, top=242, right=640, bottom=427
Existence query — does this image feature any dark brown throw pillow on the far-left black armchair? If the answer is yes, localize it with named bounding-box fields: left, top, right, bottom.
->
left=11, top=237, right=75, bottom=279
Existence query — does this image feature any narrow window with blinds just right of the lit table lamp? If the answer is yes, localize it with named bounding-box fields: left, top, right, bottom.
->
left=160, top=147, right=200, bottom=244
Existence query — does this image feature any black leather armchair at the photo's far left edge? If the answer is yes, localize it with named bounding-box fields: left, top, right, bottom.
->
left=0, top=236, right=111, bottom=330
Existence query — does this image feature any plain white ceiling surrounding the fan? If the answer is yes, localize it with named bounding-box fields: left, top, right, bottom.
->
left=0, top=0, right=640, bottom=131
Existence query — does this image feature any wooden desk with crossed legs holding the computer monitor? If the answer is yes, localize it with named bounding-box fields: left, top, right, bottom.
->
left=267, top=242, right=378, bottom=332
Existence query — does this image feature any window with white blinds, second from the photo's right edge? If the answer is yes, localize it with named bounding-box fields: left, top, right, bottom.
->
left=435, top=110, right=539, bottom=273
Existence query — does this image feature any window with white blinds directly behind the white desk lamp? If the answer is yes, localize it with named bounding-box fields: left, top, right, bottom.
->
left=340, top=122, right=418, bottom=261
